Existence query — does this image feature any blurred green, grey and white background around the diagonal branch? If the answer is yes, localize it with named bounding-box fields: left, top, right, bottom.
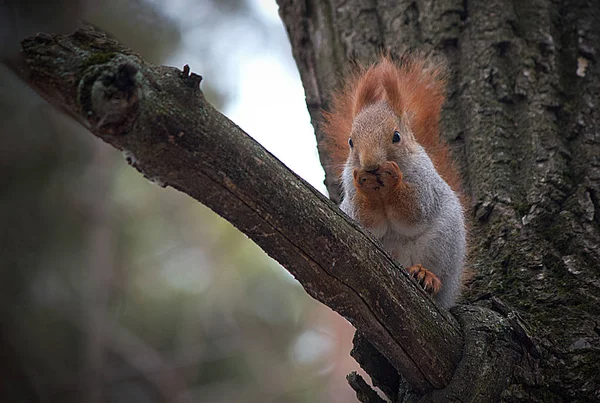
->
left=0, top=0, right=357, bottom=403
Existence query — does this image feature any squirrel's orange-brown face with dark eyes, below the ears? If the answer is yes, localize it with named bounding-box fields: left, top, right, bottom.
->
left=348, top=101, right=418, bottom=172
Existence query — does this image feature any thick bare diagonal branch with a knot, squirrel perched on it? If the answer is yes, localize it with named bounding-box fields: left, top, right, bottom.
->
left=17, top=28, right=462, bottom=393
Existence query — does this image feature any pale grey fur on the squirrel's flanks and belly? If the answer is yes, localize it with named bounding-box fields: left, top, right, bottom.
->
left=340, top=146, right=466, bottom=308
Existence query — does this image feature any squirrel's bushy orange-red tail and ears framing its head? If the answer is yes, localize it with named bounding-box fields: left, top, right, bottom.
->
left=319, top=56, right=460, bottom=195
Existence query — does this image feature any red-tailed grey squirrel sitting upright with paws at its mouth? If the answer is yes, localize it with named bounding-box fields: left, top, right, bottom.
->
left=320, top=56, right=467, bottom=308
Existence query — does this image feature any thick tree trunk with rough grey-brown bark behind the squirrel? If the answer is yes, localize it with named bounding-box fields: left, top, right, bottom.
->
left=278, top=0, right=600, bottom=402
